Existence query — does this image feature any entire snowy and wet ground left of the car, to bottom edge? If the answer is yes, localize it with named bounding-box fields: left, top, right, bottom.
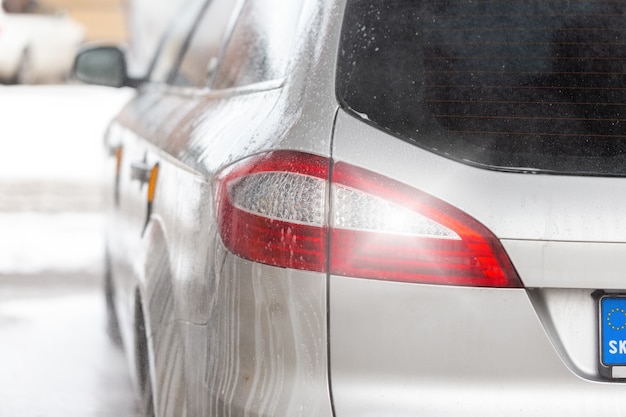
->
left=0, top=85, right=137, bottom=417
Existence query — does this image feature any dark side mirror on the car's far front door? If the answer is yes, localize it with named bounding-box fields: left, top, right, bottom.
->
left=73, top=46, right=130, bottom=87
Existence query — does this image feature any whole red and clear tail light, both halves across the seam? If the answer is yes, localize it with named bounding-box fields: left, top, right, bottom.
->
left=218, top=151, right=521, bottom=287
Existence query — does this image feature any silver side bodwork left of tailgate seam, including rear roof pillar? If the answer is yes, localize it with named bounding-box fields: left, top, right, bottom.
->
left=106, top=2, right=338, bottom=416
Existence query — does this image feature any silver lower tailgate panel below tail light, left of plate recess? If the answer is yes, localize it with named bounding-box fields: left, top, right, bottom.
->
left=329, top=277, right=624, bottom=416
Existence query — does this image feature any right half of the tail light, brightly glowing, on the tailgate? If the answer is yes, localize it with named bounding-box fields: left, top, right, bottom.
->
left=330, top=162, right=521, bottom=287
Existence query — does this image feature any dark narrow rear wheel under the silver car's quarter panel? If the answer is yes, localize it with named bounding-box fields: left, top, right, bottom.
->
left=135, top=295, right=155, bottom=417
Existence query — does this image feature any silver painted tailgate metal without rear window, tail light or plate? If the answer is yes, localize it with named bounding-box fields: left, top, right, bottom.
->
left=329, top=111, right=626, bottom=416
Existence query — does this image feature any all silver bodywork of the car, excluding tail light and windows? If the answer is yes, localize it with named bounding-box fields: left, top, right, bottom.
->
left=96, top=0, right=626, bottom=417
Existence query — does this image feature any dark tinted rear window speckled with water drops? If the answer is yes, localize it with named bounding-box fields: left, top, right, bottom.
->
left=337, top=0, right=626, bottom=176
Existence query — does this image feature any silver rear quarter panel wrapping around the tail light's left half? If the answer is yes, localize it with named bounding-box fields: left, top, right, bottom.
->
left=111, top=81, right=333, bottom=416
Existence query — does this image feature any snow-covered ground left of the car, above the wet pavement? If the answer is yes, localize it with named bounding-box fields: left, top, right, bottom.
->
left=0, top=85, right=132, bottom=275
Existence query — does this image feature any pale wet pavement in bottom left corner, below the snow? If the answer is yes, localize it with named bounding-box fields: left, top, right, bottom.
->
left=0, top=276, right=138, bottom=417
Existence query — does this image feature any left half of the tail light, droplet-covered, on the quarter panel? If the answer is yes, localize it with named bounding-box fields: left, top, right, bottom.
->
left=218, top=152, right=329, bottom=272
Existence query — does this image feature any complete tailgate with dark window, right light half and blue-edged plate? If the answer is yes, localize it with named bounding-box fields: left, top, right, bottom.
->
left=328, top=0, right=626, bottom=417
